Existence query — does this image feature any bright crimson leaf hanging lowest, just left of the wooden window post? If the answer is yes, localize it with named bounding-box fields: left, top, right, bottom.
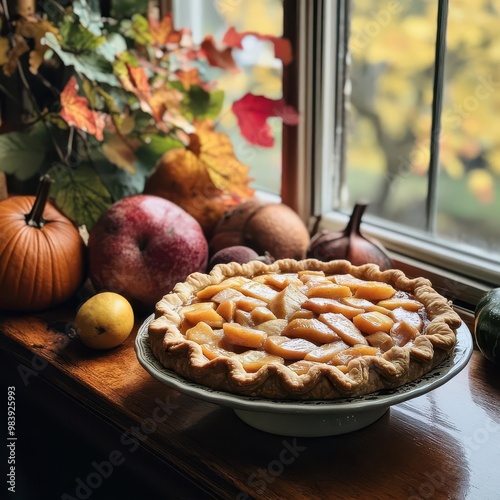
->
left=232, top=94, right=299, bottom=148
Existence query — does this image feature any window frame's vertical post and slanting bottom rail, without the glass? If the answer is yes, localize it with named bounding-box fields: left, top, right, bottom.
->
left=281, top=0, right=500, bottom=312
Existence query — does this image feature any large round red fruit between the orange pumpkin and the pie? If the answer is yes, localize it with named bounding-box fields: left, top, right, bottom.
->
left=89, top=194, right=208, bottom=312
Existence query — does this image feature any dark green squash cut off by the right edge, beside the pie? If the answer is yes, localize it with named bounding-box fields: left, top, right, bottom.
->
left=474, top=288, right=500, bottom=364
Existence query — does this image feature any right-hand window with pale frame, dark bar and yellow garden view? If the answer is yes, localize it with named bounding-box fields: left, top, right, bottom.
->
left=304, top=0, right=500, bottom=302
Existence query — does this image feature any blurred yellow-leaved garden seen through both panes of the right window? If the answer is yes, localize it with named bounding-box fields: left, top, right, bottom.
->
left=341, top=0, right=500, bottom=270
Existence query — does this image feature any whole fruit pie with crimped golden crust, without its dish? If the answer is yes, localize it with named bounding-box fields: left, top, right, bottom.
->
left=148, top=259, right=461, bottom=400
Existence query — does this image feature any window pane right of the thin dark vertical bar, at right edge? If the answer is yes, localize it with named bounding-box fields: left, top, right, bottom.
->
left=437, top=0, right=500, bottom=262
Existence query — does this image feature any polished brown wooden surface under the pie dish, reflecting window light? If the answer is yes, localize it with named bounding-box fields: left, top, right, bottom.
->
left=0, top=309, right=500, bottom=500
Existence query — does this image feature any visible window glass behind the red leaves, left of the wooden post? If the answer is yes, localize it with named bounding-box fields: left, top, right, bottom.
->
left=173, top=0, right=283, bottom=194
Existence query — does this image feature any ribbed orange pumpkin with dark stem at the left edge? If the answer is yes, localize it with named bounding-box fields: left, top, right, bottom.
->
left=0, top=175, right=85, bottom=312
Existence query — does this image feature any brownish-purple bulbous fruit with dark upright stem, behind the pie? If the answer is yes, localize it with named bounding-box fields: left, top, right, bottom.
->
left=307, top=203, right=393, bottom=270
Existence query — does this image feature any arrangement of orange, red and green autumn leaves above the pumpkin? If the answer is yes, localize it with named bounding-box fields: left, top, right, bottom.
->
left=0, top=0, right=298, bottom=229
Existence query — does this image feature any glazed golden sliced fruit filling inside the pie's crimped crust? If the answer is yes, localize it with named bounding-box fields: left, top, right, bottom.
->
left=177, top=271, right=428, bottom=375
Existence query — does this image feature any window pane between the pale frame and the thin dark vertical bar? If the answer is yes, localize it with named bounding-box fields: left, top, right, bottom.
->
left=344, top=0, right=437, bottom=230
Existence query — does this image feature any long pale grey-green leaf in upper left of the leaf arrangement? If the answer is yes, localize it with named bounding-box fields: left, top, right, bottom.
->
left=44, top=33, right=120, bottom=87
